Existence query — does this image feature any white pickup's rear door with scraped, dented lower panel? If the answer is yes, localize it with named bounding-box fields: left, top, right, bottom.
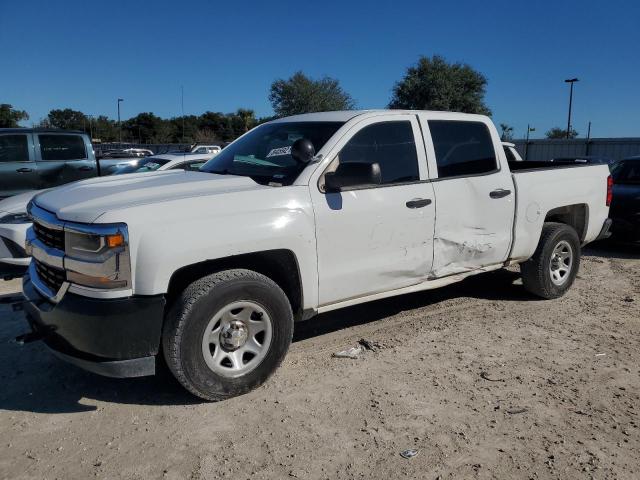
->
left=420, top=114, right=515, bottom=278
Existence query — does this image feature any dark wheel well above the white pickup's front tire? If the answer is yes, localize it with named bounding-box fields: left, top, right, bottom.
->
left=166, top=250, right=302, bottom=320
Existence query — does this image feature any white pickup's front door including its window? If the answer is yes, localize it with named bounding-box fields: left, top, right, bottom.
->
left=311, top=114, right=434, bottom=305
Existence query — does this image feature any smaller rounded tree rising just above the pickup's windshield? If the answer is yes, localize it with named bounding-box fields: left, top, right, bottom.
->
left=269, top=72, right=355, bottom=117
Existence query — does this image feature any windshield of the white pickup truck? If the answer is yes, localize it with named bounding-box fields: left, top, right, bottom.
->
left=200, top=122, right=343, bottom=185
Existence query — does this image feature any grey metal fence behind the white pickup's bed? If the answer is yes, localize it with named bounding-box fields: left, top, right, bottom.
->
left=513, top=138, right=640, bottom=161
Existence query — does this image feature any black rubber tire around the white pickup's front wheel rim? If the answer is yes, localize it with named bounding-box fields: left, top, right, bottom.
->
left=162, top=269, right=293, bottom=401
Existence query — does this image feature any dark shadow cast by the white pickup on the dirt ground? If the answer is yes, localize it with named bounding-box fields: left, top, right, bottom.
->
left=0, top=270, right=535, bottom=413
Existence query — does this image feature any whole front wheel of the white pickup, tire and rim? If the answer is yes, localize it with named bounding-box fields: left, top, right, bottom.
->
left=162, top=269, right=293, bottom=401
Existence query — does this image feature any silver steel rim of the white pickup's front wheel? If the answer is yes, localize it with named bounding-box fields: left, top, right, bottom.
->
left=202, top=301, right=273, bottom=378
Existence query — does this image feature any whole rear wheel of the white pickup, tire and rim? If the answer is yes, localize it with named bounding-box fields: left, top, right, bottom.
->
left=520, top=222, right=580, bottom=299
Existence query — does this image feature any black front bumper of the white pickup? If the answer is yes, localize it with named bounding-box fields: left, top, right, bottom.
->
left=22, top=274, right=165, bottom=377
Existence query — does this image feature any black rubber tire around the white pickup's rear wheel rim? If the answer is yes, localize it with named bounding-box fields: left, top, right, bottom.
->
left=520, top=222, right=580, bottom=299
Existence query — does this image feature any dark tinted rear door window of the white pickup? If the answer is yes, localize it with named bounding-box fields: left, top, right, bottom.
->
left=428, top=120, right=498, bottom=178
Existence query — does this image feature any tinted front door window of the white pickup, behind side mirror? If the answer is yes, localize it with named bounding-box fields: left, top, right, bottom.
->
left=339, top=120, right=420, bottom=184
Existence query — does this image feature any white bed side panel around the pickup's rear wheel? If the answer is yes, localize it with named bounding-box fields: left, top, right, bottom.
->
left=511, top=165, right=609, bottom=261
